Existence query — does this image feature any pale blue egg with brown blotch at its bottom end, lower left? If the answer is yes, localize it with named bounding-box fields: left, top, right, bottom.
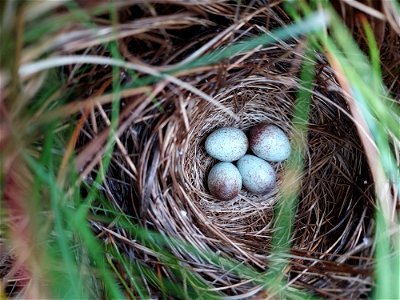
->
left=207, top=162, right=242, bottom=200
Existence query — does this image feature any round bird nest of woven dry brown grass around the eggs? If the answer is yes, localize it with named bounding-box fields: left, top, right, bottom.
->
left=74, top=2, right=373, bottom=299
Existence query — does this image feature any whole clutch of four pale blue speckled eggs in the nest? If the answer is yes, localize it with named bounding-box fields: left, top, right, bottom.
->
left=205, top=124, right=291, bottom=200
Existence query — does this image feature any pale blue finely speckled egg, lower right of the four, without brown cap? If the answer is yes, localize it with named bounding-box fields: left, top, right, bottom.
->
left=237, top=154, right=276, bottom=194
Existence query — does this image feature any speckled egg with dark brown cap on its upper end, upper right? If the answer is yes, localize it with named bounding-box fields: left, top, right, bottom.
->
left=249, top=124, right=291, bottom=162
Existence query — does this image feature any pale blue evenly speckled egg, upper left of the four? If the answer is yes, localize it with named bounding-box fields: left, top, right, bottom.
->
left=205, top=127, right=249, bottom=162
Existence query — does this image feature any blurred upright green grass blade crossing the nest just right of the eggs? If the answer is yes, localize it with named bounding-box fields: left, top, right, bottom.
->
left=265, top=39, right=315, bottom=293
